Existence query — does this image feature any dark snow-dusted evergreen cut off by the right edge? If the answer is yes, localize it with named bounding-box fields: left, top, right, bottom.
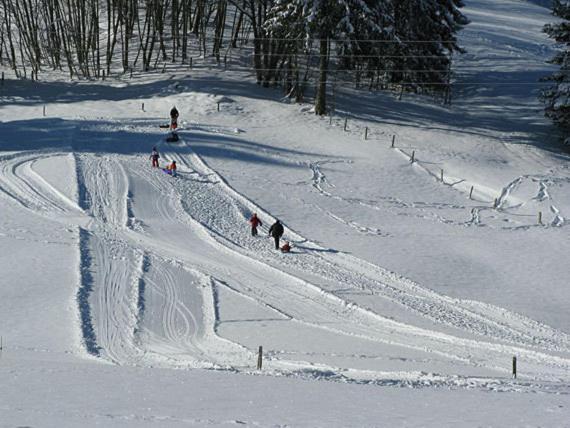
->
left=541, top=0, right=570, bottom=143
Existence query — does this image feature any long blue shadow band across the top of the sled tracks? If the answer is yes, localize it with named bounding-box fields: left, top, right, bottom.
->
left=0, top=118, right=338, bottom=168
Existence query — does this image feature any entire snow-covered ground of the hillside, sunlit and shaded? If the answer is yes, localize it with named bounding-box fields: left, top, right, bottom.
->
left=0, top=0, right=570, bottom=427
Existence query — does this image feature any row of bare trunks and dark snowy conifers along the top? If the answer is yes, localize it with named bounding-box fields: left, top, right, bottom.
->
left=0, top=0, right=468, bottom=114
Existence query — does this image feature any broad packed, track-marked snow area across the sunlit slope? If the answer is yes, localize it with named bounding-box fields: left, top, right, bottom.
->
left=0, top=141, right=570, bottom=392
